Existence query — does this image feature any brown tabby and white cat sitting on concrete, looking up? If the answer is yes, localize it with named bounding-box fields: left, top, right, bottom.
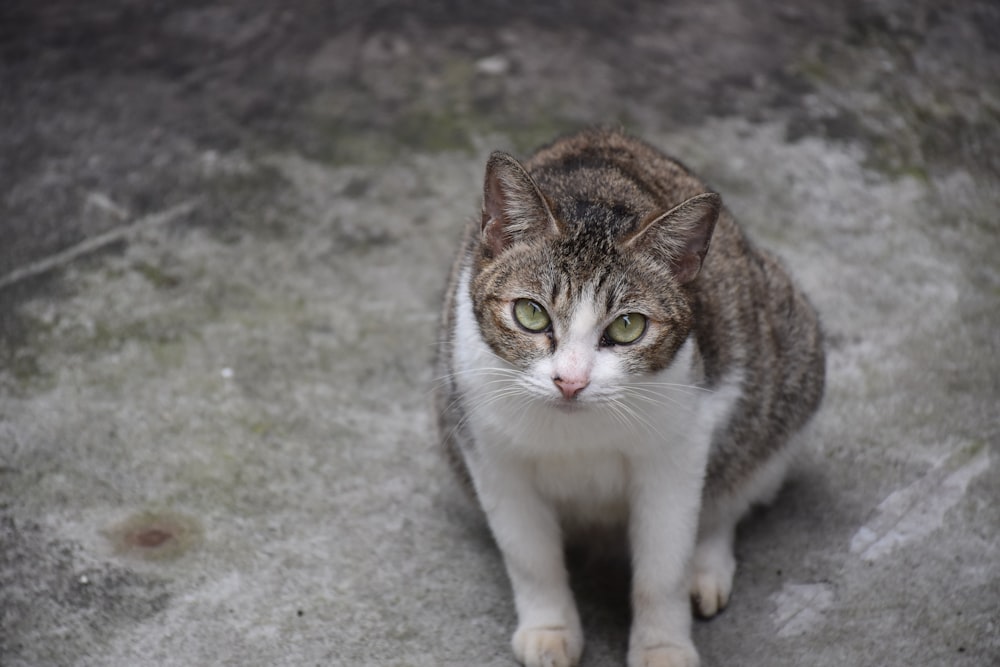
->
left=436, top=128, right=825, bottom=667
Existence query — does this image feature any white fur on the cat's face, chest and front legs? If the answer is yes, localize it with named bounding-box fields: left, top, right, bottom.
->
left=452, top=269, right=741, bottom=667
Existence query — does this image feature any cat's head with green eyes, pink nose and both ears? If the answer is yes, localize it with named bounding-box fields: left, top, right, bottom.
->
left=471, top=153, right=721, bottom=406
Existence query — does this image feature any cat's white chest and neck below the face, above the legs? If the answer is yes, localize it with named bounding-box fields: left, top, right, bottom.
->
left=452, top=264, right=738, bottom=524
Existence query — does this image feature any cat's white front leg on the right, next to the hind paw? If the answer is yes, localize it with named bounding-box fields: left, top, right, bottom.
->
left=628, top=459, right=701, bottom=667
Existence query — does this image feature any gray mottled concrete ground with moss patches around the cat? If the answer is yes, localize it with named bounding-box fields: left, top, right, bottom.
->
left=0, top=0, right=1000, bottom=667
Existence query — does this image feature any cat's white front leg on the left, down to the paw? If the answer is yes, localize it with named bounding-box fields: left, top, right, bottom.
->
left=472, top=452, right=583, bottom=667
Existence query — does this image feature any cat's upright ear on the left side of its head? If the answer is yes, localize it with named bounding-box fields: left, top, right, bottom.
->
left=481, top=151, right=560, bottom=257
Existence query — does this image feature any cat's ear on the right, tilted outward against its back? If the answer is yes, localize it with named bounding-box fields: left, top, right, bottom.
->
left=625, top=192, right=722, bottom=285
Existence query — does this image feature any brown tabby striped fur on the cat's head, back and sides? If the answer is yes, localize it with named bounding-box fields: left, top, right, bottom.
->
left=437, top=129, right=825, bottom=498
